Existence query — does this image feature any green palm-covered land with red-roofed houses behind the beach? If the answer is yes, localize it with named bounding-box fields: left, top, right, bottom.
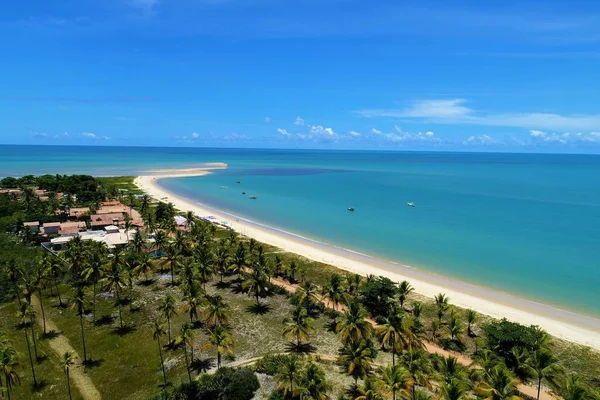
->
left=0, top=175, right=600, bottom=400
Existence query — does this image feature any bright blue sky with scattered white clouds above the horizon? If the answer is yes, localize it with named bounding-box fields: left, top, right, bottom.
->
left=0, top=0, right=600, bottom=153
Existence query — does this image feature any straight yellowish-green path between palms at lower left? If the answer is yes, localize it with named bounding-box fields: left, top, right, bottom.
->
left=31, top=295, right=102, bottom=400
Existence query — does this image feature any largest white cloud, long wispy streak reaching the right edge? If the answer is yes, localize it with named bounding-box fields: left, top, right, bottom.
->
left=358, top=99, right=600, bottom=131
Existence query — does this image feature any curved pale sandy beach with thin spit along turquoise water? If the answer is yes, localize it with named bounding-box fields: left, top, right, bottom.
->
left=135, top=167, right=600, bottom=350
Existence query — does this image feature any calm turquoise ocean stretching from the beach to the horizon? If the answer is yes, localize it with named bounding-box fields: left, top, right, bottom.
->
left=0, top=146, right=600, bottom=317
